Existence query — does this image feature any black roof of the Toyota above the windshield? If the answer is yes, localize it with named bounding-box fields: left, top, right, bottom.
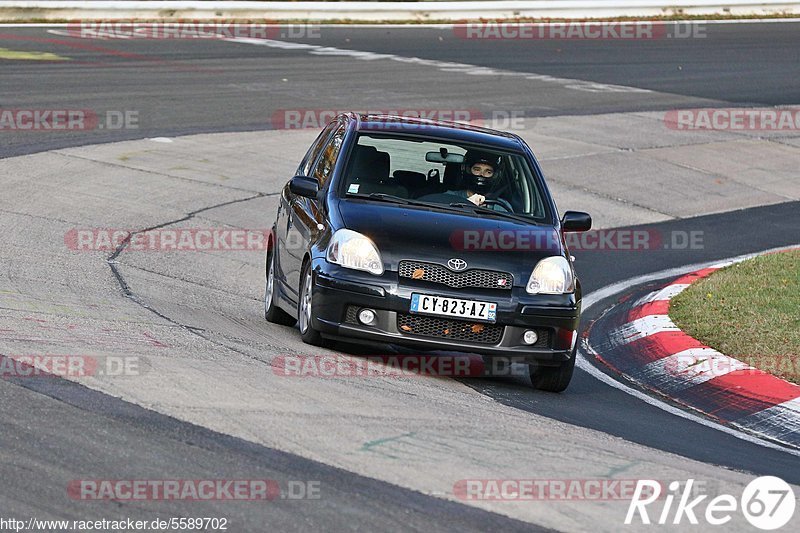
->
left=343, top=113, right=524, bottom=151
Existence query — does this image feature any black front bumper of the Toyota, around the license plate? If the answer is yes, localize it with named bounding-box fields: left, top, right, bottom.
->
left=312, top=259, right=580, bottom=364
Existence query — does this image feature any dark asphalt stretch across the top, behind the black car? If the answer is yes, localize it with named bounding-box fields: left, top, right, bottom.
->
left=0, top=23, right=800, bottom=157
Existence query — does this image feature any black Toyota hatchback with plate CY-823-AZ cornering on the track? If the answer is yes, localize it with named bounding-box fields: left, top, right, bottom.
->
left=264, top=113, right=591, bottom=391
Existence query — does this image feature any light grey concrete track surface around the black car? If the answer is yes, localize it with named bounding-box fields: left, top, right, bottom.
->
left=0, top=108, right=800, bottom=531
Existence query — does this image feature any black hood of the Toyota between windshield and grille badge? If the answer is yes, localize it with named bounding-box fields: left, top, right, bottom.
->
left=339, top=200, right=563, bottom=286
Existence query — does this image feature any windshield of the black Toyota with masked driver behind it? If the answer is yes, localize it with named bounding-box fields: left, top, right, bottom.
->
left=336, top=133, right=550, bottom=222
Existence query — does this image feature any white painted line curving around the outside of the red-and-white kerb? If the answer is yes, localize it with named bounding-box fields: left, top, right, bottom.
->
left=575, top=245, right=800, bottom=457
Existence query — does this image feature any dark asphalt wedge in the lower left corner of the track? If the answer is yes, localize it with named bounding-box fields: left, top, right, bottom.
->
left=0, top=364, right=548, bottom=531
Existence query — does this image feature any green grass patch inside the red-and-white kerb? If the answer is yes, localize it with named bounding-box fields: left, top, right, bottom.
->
left=669, top=250, right=800, bottom=383
